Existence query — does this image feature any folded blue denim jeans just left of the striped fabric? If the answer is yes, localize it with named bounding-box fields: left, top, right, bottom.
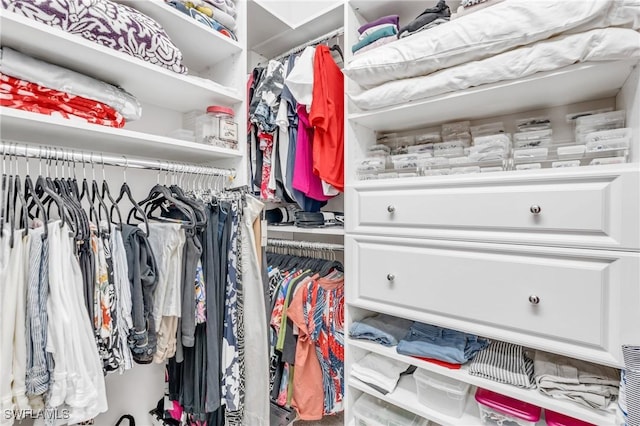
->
left=396, top=322, right=489, bottom=364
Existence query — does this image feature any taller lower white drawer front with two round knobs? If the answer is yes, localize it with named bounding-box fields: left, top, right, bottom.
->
left=347, top=236, right=640, bottom=365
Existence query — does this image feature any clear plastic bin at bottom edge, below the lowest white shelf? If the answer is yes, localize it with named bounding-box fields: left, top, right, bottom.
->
left=353, top=394, right=429, bottom=426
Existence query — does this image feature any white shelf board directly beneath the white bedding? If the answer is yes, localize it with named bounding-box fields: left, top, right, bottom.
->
left=348, top=59, right=638, bottom=131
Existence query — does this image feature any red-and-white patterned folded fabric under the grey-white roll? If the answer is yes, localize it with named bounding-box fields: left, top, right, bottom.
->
left=0, top=73, right=125, bottom=128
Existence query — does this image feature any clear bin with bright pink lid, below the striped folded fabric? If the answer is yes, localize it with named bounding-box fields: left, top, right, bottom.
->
left=476, top=388, right=542, bottom=426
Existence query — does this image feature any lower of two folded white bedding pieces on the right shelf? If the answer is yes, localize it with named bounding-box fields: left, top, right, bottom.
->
left=349, top=28, right=640, bottom=110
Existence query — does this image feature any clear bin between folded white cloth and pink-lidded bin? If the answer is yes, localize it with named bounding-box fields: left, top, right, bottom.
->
left=413, top=368, right=471, bottom=418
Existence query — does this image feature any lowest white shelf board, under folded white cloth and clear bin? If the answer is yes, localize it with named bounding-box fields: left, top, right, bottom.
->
left=348, top=376, right=482, bottom=426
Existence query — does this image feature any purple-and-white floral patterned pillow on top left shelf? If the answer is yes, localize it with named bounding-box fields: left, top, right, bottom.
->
left=2, top=0, right=187, bottom=74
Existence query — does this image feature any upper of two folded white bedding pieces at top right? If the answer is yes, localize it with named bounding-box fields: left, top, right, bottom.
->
left=345, top=0, right=640, bottom=88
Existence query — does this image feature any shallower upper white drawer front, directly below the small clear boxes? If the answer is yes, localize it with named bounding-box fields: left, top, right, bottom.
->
left=351, top=165, right=640, bottom=250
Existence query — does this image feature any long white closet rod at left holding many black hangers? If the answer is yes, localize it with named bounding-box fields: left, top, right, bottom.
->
left=2, top=140, right=236, bottom=177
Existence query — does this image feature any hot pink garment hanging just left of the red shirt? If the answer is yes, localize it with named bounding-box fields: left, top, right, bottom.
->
left=293, top=104, right=333, bottom=201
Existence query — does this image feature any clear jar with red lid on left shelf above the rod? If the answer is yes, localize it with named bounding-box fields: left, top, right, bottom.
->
left=196, top=105, right=238, bottom=149
